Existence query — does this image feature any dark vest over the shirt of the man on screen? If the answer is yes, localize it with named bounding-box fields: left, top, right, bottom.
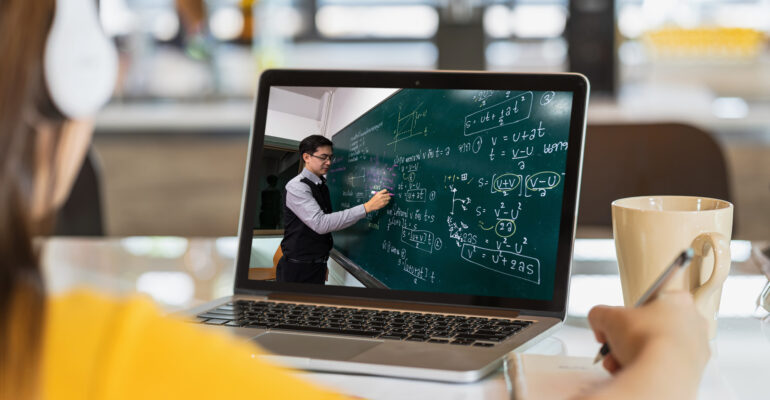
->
left=281, top=178, right=333, bottom=261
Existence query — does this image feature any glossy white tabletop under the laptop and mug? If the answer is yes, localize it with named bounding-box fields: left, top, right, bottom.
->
left=42, top=237, right=770, bottom=399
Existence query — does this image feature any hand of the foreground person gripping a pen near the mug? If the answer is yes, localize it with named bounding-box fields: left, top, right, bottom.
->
left=583, top=292, right=710, bottom=400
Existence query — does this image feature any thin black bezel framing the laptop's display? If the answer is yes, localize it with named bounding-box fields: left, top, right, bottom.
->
left=234, top=70, right=589, bottom=319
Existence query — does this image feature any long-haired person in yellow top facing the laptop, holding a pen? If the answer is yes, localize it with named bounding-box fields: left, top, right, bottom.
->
left=0, top=0, right=708, bottom=399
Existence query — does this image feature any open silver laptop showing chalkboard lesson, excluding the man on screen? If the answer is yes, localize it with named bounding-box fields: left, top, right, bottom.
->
left=186, top=70, right=589, bottom=382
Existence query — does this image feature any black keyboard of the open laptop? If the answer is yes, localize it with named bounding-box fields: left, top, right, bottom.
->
left=197, top=300, right=532, bottom=347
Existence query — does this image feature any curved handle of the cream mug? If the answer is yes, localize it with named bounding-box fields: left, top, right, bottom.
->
left=692, top=232, right=730, bottom=305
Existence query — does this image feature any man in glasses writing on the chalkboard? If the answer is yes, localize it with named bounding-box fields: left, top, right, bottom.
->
left=275, top=135, right=390, bottom=284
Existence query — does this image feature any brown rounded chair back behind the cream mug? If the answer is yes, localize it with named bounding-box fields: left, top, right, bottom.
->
left=578, top=123, right=735, bottom=232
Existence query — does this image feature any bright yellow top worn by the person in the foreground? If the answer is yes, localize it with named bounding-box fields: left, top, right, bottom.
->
left=42, top=290, right=342, bottom=400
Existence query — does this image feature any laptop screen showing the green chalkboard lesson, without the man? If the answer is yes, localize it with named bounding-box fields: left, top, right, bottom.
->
left=236, top=71, right=587, bottom=318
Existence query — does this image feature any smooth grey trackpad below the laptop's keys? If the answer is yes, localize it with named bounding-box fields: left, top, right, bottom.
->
left=251, top=332, right=382, bottom=361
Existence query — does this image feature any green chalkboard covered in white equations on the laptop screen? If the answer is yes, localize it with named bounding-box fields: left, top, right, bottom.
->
left=328, top=89, right=573, bottom=300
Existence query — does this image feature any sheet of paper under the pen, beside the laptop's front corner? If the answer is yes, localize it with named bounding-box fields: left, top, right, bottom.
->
left=507, top=353, right=610, bottom=400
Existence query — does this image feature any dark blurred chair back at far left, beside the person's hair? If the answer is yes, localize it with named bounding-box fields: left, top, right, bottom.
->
left=53, top=147, right=104, bottom=236
